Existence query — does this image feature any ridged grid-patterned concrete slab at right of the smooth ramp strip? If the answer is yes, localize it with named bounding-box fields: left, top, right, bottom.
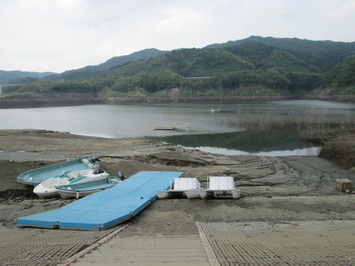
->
left=197, top=221, right=355, bottom=265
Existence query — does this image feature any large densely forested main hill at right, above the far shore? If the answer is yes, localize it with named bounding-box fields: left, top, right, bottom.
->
left=95, top=37, right=355, bottom=96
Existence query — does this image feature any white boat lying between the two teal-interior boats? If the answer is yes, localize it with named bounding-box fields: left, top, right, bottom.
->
left=33, top=168, right=109, bottom=198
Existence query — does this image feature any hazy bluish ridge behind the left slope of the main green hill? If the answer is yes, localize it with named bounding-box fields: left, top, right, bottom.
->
left=45, top=48, right=167, bottom=81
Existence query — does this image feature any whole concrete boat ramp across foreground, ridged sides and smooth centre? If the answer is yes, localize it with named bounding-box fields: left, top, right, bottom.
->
left=0, top=220, right=355, bottom=266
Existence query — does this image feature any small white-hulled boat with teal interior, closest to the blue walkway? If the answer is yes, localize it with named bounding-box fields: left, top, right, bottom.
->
left=56, top=176, right=123, bottom=199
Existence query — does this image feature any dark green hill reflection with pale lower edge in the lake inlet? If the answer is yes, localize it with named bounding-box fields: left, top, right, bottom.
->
left=153, top=128, right=320, bottom=156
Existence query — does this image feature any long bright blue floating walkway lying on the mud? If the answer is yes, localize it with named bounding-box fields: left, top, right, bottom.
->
left=17, top=171, right=183, bottom=230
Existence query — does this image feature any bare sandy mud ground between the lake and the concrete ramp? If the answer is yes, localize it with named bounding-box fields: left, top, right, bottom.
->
left=0, top=130, right=355, bottom=265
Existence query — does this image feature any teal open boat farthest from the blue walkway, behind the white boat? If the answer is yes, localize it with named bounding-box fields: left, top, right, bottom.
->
left=17, top=156, right=100, bottom=186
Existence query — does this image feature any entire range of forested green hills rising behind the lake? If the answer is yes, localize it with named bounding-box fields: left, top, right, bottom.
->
left=2, top=36, right=355, bottom=102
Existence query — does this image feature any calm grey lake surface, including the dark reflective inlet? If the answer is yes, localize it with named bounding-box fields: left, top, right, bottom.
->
left=0, top=100, right=355, bottom=156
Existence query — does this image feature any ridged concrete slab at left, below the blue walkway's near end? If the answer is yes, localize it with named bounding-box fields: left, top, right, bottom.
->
left=0, top=225, right=117, bottom=266
